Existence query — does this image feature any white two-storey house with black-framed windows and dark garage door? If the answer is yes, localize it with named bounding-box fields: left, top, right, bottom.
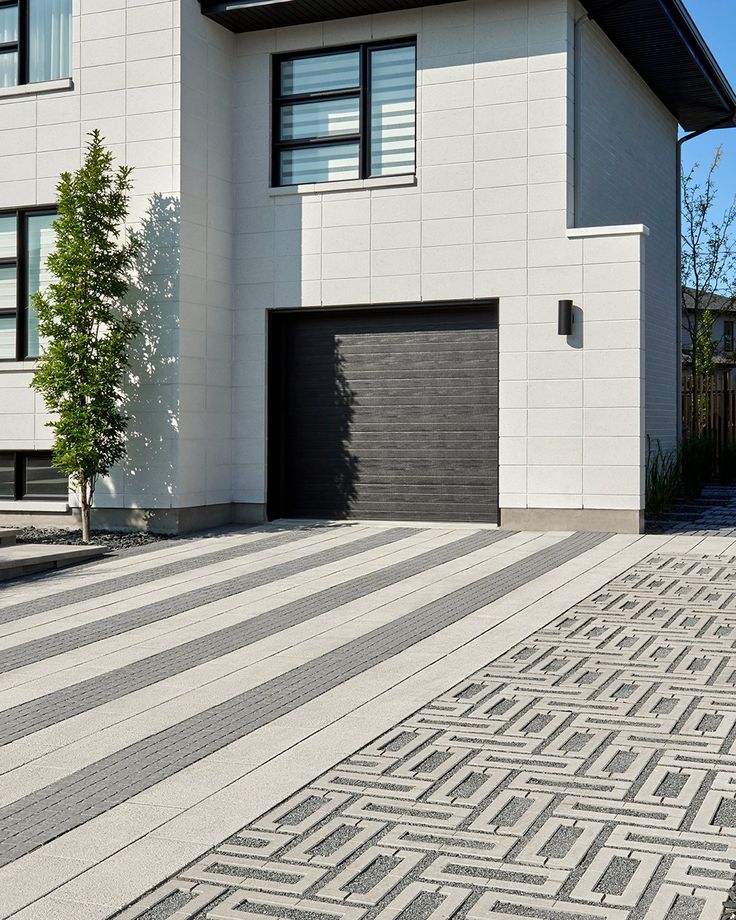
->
left=0, top=0, right=736, bottom=531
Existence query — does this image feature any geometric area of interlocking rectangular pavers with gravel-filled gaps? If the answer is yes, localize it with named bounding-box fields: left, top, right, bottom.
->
left=110, top=553, right=736, bottom=920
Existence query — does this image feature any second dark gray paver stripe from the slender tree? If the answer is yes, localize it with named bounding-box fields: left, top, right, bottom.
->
left=0, top=527, right=421, bottom=672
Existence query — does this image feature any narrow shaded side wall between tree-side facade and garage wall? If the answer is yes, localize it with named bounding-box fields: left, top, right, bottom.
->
left=177, top=0, right=235, bottom=508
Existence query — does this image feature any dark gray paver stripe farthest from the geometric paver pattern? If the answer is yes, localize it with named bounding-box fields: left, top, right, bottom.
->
left=0, top=529, right=314, bottom=625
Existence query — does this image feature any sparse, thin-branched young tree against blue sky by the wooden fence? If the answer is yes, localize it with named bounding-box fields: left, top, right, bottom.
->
left=681, top=147, right=736, bottom=434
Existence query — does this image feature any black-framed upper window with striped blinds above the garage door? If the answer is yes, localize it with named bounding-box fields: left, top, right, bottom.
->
left=272, top=40, right=416, bottom=185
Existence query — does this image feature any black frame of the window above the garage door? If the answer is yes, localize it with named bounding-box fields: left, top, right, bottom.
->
left=271, top=36, right=417, bottom=188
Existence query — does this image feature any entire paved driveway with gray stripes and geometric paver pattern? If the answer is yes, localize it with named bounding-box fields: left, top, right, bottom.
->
left=0, top=500, right=736, bottom=920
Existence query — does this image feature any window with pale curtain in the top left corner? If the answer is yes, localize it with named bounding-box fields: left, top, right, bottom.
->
left=0, top=0, right=72, bottom=87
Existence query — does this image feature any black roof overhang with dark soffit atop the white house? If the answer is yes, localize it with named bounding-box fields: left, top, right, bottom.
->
left=199, top=0, right=736, bottom=131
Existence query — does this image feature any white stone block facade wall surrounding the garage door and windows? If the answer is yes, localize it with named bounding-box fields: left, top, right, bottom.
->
left=0, top=0, right=675, bottom=514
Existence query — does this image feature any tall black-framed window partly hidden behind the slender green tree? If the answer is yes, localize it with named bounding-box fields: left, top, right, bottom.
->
left=0, top=209, right=56, bottom=361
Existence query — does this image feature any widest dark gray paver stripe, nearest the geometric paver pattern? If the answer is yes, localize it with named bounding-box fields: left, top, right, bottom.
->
left=0, top=534, right=608, bottom=865
